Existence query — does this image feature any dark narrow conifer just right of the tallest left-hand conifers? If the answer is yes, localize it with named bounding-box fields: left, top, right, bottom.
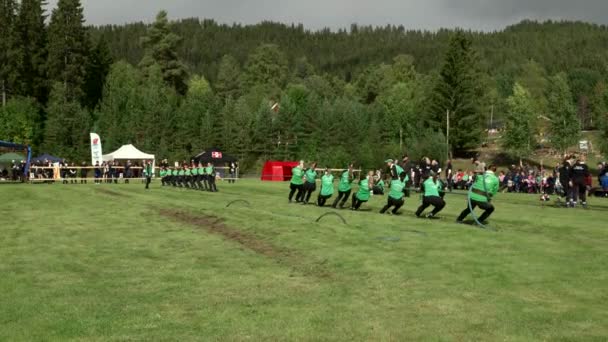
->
left=84, top=37, right=112, bottom=110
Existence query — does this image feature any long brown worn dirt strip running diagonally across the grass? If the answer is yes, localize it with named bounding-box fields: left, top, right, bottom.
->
left=158, top=209, right=332, bottom=278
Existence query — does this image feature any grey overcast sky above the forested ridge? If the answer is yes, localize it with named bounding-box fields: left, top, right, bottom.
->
left=44, top=0, right=608, bottom=30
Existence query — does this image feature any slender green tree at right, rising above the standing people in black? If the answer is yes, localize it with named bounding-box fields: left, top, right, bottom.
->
left=547, top=74, right=581, bottom=152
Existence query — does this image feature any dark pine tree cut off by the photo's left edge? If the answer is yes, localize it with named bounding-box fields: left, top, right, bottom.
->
left=0, top=0, right=23, bottom=106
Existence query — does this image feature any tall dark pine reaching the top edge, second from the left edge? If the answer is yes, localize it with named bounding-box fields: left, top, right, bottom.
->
left=17, top=0, right=48, bottom=105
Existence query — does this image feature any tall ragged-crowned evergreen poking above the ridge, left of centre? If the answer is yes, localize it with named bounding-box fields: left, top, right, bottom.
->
left=140, top=11, right=188, bottom=95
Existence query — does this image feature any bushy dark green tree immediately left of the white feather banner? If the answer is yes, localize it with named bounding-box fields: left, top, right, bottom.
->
left=44, top=82, right=91, bottom=159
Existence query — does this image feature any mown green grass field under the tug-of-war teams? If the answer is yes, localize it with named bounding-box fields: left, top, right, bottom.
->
left=0, top=181, right=608, bottom=341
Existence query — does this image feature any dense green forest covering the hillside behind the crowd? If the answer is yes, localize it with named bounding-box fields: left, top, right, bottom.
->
left=0, top=0, right=608, bottom=167
